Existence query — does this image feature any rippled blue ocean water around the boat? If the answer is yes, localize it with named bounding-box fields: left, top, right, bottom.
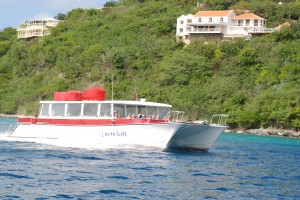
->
left=0, top=119, right=300, bottom=200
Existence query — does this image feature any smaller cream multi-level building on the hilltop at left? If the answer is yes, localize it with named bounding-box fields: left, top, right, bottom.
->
left=17, top=18, right=60, bottom=39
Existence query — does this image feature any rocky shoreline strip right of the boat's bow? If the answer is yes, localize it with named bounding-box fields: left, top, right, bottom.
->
left=225, top=128, right=300, bottom=138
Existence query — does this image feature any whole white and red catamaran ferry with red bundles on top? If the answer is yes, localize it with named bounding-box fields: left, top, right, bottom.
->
left=6, top=88, right=228, bottom=151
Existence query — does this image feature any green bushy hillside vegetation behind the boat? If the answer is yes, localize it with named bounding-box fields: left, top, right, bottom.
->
left=0, top=0, right=300, bottom=129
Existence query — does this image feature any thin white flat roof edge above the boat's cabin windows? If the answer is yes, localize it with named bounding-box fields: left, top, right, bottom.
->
left=40, top=100, right=172, bottom=108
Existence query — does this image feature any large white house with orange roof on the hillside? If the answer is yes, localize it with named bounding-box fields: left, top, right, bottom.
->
left=176, top=10, right=274, bottom=44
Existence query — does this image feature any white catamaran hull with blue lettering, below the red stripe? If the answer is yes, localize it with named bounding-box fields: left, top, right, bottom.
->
left=7, top=123, right=227, bottom=150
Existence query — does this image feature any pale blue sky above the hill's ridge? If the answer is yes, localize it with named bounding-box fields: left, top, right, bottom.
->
left=0, top=0, right=109, bottom=31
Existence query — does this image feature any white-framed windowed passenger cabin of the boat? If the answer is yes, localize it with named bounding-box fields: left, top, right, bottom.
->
left=39, top=101, right=172, bottom=120
